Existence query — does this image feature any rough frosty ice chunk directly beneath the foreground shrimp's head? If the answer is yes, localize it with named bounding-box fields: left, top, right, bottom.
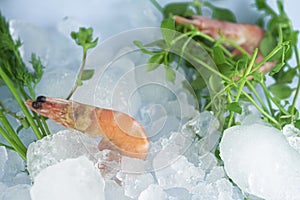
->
left=27, top=130, right=99, bottom=178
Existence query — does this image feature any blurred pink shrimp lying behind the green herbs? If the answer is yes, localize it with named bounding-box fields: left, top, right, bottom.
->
left=174, top=16, right=276, bottom=73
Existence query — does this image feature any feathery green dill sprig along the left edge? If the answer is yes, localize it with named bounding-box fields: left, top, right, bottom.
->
left=0, top=14, right=50, bottom=159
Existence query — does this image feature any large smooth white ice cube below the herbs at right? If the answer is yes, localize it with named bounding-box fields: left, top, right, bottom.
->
left=220, top=124, right=300, bottom=200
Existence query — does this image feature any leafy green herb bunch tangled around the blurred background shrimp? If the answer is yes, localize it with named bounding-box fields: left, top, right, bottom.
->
left=141, top=0, right=300, bottom=129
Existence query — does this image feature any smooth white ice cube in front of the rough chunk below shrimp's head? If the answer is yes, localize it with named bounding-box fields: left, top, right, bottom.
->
left=30, top=156, right=105, bottom=200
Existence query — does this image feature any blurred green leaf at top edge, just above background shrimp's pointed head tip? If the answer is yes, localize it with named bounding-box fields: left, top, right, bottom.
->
left=163, top=2, right=191, bottom=18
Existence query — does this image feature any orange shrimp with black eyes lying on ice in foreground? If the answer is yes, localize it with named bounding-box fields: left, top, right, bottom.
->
left=25, top=96, right=149, bottom=160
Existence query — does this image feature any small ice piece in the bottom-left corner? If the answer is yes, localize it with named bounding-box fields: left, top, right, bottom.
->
left=0, top=184, right=31, bottom=200
